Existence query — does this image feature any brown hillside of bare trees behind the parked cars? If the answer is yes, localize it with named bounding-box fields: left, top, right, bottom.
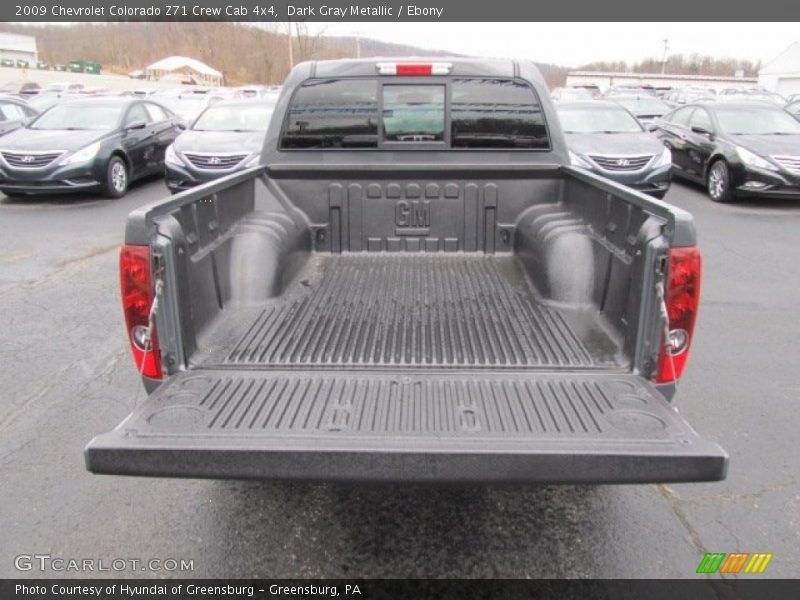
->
left=0, top=22, right=760, bottom=88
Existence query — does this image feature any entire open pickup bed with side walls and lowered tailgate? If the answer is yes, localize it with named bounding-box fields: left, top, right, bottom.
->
left=86, top=164, right=727, bottom=482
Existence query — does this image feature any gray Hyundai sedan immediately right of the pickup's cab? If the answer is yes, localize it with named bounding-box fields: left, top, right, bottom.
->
left=556, top=100, right=672, bottom=198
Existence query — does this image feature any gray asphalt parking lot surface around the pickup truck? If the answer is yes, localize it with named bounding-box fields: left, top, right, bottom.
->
left=0, top=180, right=800, bottom=578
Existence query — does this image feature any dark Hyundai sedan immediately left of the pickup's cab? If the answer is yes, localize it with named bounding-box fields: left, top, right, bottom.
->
left=165, top=100, right=273, bottom=193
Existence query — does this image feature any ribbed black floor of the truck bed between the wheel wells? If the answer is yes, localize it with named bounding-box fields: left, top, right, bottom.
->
left=197, top=254, right=627, bottom=369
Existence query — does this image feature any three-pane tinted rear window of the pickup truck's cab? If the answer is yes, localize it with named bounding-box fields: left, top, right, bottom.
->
left=280, top=77, right=550, bottom=150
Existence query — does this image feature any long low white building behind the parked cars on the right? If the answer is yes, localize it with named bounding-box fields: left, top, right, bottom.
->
left=567, top=71, right=756, bottom=91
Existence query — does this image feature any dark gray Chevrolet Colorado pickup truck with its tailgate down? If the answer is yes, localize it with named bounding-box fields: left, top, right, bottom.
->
left=85, top=58, right=728, bottom=483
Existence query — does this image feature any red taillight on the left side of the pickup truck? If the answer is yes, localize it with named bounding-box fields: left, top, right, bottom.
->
left=119, top=244, right=163, bottom=379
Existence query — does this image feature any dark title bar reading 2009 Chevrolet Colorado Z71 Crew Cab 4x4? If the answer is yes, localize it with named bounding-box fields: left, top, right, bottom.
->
left=0, top=0, right=798, bottom=22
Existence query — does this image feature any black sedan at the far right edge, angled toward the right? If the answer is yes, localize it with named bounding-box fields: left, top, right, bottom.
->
left=656, top=102, right=800, bottom=202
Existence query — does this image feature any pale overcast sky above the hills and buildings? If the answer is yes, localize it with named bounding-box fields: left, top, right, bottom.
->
left=308, top=23, right=800, bottom=67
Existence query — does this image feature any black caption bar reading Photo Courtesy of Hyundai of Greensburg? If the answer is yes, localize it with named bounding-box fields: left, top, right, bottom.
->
left=0, top=575, right=800, bottom=600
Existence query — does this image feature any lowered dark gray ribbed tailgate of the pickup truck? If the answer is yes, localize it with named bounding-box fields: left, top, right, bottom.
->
left=86, top=369, right=728, bottom=483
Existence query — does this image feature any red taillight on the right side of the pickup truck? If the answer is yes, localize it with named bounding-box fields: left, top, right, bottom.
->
left=656, top=247, right=702, bottom=383
